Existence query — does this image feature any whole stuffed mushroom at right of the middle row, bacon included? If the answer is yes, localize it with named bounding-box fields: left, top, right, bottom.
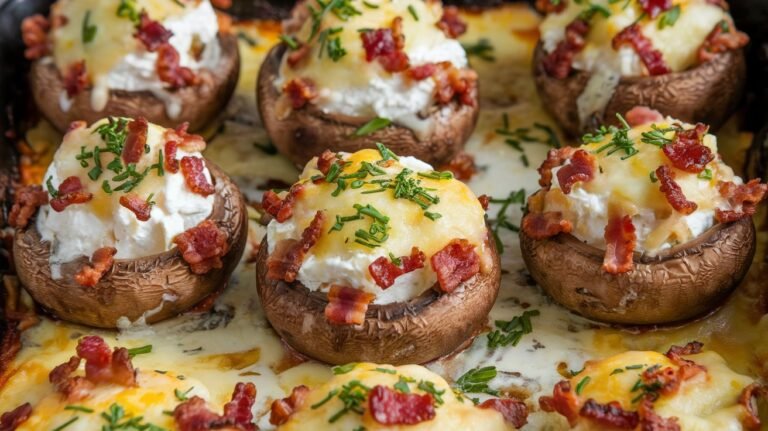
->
left=520, top=108, right=768, bottom=324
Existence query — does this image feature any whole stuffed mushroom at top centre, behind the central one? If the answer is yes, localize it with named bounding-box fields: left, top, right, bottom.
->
left=258, top=0, right=478, bottom=166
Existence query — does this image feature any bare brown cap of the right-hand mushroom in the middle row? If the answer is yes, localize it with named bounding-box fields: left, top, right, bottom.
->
left=520, top=218, right=755, bottom=325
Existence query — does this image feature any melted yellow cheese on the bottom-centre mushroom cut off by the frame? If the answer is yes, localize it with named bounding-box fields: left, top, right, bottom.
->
left=277, top=363, right=514, bottom=431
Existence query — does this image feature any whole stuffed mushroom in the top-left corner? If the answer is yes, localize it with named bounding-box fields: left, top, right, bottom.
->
left=22, top=0, right=240, bottom=132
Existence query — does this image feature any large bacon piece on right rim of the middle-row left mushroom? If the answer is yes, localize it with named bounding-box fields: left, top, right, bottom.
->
left=173, top=220, right=229, bottom=274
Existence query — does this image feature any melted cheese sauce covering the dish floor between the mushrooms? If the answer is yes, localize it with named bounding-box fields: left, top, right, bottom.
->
left=0, top=5, right=768, bottom=430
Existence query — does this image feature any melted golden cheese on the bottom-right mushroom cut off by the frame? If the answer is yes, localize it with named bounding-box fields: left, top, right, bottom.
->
left=570, top=351, right=753, bottom=431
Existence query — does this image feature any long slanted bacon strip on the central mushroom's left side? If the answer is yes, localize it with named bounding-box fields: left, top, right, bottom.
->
left=267, top=211, right=325, bottom=283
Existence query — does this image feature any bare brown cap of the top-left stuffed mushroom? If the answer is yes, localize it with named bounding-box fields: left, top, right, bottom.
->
left=29, top=33, right=240, bottom=132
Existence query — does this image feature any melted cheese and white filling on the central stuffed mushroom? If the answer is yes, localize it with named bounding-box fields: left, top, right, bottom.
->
left=267, top=150, right=489, bottom=303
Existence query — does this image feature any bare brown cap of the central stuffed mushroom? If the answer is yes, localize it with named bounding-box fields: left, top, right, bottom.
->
left=256, top=238, right=501, bottom=365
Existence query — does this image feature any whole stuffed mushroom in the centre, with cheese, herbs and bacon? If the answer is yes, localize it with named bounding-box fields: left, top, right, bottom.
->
left=257, top=145, right=500, bottom=364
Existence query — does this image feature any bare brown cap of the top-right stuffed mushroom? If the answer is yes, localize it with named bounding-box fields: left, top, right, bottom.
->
left=533, top=42, right=747, bottom=137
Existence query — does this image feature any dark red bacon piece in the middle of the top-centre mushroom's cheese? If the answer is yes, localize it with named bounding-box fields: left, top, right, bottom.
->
left=360, top=17, right=410, bottom=72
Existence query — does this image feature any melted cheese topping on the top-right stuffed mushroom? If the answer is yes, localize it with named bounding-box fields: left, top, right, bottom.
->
left=540, top=0, right=728, bottom=76
